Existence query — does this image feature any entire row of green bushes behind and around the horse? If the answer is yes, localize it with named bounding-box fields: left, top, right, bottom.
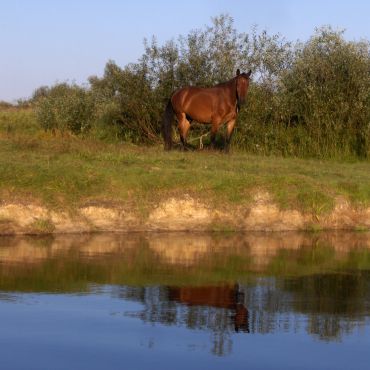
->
left=33, top=14, right=370, bottom=157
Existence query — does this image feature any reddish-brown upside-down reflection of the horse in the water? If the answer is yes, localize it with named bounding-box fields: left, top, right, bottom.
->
left=169, top=284, right=249, bottom=333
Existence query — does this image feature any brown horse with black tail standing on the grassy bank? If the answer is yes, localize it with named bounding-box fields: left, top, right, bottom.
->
left=162, top=69, right=252, bottom=151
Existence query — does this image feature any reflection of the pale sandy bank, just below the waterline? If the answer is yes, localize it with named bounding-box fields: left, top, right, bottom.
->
left=0, top=232, right=370, bottom=270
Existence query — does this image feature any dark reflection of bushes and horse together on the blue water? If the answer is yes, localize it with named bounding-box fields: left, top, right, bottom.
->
left=115, top=272, right=370, bottom=355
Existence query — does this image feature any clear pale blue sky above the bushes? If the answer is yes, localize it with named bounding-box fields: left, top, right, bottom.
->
left=0, top=0, right=370, bottom=102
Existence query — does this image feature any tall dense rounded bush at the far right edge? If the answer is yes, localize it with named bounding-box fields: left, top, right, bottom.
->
left=280, top=28, right=370, bottom=157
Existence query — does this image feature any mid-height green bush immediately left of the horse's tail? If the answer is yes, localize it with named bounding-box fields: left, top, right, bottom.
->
left=89, top=62, right=161, bottom=143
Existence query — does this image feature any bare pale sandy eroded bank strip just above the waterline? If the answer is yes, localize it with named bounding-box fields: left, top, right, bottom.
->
left=0, top=193, right=370, bottom=235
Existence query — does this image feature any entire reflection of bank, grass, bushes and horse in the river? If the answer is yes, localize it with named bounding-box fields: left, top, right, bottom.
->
left=0, top=233, right=370, bottom=355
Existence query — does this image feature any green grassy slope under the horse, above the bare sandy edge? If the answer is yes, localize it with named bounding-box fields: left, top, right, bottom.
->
left=0, top=110, right=370, bottom=214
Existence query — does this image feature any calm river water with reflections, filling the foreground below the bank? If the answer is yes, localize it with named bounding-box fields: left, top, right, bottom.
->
left=0, top=233, right=370, bottom=370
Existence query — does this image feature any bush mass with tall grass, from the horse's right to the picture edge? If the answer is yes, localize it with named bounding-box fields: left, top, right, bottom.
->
left=238, top=28, right=370, bottom=158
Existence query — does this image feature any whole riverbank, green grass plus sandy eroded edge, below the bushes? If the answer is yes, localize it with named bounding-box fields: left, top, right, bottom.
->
left=0, top=111, right=370, bottom=234
